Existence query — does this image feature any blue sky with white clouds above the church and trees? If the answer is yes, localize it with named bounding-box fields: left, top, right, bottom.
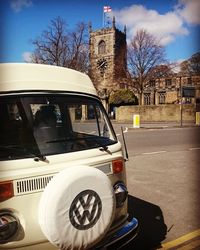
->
left=0, top=0, right=200, bottom=62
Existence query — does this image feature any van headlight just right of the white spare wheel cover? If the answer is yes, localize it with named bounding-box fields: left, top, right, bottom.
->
left=114, top=182, right=128, bottom=207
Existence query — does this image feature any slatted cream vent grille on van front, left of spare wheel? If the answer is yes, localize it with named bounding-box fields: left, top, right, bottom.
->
left=14, top=175, right=54, bottom=195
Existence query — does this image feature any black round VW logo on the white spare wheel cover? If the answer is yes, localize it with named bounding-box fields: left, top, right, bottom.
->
left=69, top=190, right=102, bottom=230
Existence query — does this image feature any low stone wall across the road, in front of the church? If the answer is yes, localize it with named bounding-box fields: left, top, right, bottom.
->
left=116, top=104, right=196, bottom=123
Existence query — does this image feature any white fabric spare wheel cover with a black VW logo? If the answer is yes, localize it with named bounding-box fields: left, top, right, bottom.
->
left=39, top=166, right=115, bottom=250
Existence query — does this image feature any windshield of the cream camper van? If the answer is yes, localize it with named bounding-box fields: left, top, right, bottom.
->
left=0, top=94, right=117, bottom=160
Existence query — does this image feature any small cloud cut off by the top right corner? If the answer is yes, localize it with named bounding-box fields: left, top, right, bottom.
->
left=177, top=0, right=200, bottom=24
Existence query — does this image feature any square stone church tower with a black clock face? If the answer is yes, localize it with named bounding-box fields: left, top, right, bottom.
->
left=89, top=17, right=127, bottom=97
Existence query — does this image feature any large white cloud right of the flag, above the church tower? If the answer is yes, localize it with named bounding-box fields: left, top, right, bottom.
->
left=114, top=3, right=189, bottom=45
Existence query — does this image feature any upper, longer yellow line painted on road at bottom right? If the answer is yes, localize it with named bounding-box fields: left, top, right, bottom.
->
left=162, top=229, right=200, bottom=250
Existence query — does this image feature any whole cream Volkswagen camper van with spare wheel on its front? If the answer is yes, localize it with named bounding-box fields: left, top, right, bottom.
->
left=0, top=63, right=138, bottom=250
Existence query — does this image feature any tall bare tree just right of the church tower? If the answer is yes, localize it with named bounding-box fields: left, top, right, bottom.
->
left=128, top=29, right=165, bottom=104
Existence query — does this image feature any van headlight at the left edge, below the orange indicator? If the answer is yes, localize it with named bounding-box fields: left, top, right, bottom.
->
left=0, top=211, right=19, bottom=244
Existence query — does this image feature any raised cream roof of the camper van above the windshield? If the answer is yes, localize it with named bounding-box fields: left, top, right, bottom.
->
left=0, top=63, right=97, bottom=95
